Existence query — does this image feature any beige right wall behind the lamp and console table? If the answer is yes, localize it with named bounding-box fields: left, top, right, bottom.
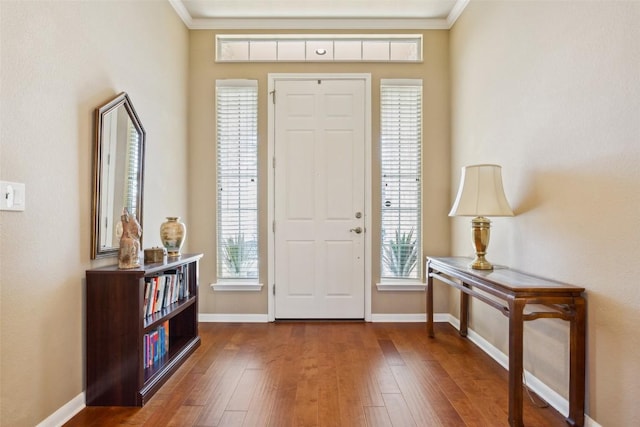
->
left=451, top=1, right=640, bottom=426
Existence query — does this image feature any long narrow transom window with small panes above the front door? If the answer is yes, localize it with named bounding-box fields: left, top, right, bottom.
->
left=216, top=34, right=422, bottom=63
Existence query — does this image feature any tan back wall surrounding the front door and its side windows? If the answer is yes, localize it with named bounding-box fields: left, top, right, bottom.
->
left=188, top=30, right=450, bottom=314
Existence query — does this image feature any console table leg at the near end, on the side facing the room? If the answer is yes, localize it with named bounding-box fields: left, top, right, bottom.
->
left=509, top=298, right=526, bottom=427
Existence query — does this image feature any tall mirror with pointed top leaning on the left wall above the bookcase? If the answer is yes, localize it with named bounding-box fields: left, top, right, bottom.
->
left=91, top=92, right=145, bottom=259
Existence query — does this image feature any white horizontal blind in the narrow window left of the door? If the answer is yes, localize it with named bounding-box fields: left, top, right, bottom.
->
left=216, top=80, right=258, bottom=279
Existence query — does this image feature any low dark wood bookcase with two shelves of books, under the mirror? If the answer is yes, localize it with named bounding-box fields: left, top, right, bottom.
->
left=86, top=254, right=202, bottom=406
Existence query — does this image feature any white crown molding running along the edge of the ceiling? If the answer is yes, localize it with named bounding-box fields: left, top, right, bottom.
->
left=169, top=0, right=470, bottom=30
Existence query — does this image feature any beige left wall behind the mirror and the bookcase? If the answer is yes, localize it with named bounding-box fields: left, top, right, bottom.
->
left=0, top=0, right=188, bottom=426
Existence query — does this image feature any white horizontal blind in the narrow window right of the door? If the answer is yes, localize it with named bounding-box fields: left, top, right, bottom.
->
left=380, top=79, right=422, bottom=279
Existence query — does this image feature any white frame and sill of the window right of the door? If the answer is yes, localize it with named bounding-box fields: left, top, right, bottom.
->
left=377, top=79, right=425, bottom=291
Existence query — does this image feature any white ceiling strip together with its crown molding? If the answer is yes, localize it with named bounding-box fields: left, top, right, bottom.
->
left=169, top=0, right=469, bottom=30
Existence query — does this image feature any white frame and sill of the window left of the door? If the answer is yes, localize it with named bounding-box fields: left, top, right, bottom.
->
left=211, top=79, right=262, bottom=291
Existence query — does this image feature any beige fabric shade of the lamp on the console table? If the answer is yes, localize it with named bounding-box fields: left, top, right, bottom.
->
left=449, top=165, right=513, bottom=216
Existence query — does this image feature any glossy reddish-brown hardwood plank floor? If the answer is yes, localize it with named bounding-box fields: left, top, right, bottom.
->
left=66, top=322, right=566, bottom=427
